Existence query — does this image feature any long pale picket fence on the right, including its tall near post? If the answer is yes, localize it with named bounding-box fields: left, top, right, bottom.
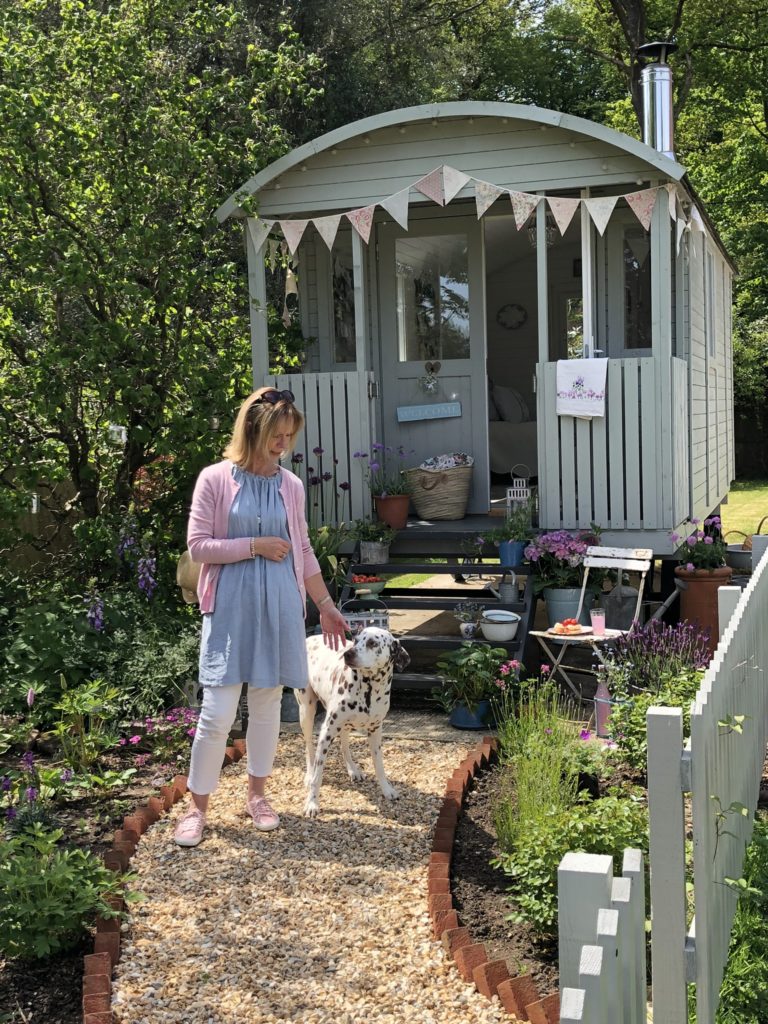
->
left=648, top=557, right=768, bottom=1024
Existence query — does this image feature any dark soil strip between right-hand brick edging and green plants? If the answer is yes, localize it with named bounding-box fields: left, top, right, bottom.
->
left=451, top=765, right=558, bottom=994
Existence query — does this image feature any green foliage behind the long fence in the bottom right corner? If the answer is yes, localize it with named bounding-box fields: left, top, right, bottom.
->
left=716, top=817, right=768, bottom=1024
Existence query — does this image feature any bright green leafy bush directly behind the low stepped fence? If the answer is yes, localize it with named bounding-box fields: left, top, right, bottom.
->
left=497, top=795, right=648, bottom=935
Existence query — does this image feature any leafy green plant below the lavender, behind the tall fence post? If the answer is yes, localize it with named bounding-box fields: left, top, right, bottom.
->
left=610, top=669, right=701, bottom=776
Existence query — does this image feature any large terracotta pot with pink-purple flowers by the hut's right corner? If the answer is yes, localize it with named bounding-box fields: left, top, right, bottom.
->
left=670, top=515, right=733, bottom=654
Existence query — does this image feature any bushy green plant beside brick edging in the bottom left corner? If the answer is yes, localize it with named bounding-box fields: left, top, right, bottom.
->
left=0, top=824, right=128, bottom=959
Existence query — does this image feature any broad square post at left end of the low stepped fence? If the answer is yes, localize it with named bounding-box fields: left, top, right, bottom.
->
left=557, top=853, right=613, bottom=995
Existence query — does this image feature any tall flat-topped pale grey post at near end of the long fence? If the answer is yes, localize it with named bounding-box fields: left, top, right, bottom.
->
left=646, top=708, right=688, bottom=1024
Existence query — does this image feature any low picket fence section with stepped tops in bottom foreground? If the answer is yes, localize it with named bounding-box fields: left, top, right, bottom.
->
left=557, top=850, right=646, bottom=1024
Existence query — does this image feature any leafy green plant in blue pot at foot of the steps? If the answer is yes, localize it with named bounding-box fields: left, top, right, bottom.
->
left=432, top=642, right=507, bottom=729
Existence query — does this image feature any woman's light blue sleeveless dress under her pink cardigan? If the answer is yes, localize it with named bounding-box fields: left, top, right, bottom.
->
left=200, top=466, right=307, bottom=689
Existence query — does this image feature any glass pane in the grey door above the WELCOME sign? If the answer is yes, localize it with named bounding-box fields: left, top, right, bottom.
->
left=395, top=234, right=469, bottom=362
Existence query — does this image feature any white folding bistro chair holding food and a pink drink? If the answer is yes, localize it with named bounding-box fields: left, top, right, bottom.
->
left=530, top=547, right=653, bottom=700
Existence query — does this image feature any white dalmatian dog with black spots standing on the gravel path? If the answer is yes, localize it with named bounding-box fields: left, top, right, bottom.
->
left=294, top=627, right=411, bottom=818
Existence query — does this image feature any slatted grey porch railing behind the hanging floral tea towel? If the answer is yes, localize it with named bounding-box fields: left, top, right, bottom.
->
left=537, top=357, right=688, bottom=529
